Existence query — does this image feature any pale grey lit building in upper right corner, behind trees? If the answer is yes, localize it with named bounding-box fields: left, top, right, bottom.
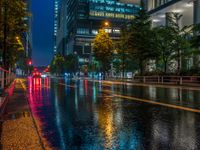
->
left=147, top=0, right=200, bottom=68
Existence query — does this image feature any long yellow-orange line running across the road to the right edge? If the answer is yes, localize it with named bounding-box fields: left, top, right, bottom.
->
left=103, top=90, right=200, bottom=113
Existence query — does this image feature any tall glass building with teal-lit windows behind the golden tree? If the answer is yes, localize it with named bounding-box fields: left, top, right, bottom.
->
left=56, top=0, right=140, bottom=64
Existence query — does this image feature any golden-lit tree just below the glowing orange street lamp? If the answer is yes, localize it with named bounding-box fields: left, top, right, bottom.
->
left=93, top=29, right=113, bottom=74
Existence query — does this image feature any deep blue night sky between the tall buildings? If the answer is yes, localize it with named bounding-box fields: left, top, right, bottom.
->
left=32, top=0, right=54, bottom=66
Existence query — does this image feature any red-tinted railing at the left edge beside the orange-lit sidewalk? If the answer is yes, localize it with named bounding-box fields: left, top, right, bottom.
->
left=0, top=67, right=15, bottom=89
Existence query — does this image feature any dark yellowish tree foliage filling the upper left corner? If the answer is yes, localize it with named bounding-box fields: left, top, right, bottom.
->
left=0, top=0, right=28, bottom=68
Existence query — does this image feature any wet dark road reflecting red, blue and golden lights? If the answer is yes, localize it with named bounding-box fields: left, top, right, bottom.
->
left=28, top=78, right=200, bottom=150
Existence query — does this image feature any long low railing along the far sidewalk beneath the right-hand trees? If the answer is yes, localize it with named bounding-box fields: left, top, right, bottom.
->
left=108, top=76, right=200, bottom=86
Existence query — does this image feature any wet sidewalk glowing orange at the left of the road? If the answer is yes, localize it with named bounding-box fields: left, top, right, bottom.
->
left=0, top=79, right=43, bottom=150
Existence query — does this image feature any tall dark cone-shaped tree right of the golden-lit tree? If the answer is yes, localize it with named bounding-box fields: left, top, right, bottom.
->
left=126, top=5, right=157, bottom=74
